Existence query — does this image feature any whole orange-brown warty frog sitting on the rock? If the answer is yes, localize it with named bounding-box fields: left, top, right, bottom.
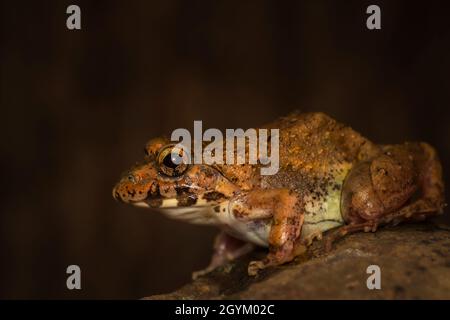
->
left=112, top=112, right=446, bottom=279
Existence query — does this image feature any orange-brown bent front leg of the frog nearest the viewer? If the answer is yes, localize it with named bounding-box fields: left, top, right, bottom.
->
left=230, top=189, right=304, bottom=275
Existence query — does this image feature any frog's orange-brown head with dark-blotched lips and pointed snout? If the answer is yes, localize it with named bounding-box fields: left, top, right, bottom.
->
left=113, top=138, right=244, bottom=223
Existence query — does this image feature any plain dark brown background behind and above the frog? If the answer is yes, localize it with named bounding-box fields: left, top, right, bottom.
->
left=0, top=0, right=450, bottom=298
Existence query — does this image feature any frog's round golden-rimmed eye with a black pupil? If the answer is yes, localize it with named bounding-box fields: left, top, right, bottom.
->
left=158, top=146, right=188, bottom=177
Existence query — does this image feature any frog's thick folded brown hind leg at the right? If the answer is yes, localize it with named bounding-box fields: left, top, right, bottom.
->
left=325, top=143, right=444, bottom=250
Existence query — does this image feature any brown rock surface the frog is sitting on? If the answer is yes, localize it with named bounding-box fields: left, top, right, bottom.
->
left=145, top=223, right=450, bottom=299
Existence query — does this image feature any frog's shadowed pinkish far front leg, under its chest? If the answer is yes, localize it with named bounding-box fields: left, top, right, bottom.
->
left=192, top=231, right=254, bottom=280
